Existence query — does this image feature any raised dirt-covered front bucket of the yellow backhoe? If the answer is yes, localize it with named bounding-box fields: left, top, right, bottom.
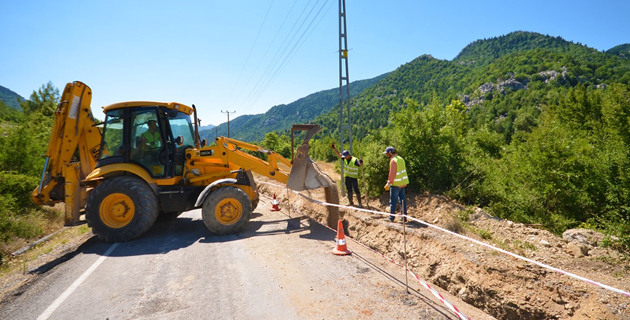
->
left=287, top=124, right=334, bottom=191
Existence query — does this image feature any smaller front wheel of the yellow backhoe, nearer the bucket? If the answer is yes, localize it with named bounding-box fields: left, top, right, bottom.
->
left=201, top=187, right=252, bottom=235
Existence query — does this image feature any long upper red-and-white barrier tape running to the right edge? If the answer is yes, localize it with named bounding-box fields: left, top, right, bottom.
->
left=259, top=182, right=630, bottom=297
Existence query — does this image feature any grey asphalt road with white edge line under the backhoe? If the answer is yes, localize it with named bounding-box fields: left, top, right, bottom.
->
left=0, top=201, right=491, bottom=320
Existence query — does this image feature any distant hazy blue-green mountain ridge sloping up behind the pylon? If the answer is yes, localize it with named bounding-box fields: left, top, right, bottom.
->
left=199, top=74, right=387, bottom=141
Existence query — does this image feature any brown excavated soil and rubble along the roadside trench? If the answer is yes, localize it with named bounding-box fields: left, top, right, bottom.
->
left=256, top=163, right=630, bottom=319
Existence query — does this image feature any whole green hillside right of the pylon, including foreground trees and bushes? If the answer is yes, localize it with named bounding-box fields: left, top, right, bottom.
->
left=311, top=32, right=630, bottom=250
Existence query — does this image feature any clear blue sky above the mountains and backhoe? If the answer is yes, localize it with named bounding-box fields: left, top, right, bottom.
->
left=0, top=0, right=630, bottom=125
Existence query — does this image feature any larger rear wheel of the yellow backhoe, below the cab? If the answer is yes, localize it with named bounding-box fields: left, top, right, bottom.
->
left=85, top=177, right=159, bottom=242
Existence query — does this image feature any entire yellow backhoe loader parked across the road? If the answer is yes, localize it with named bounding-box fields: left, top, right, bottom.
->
left=32, top=82, right=335, bottom=242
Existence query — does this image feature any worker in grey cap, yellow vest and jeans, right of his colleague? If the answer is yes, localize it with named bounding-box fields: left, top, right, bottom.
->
left=383, top=147, right=409, bottom=222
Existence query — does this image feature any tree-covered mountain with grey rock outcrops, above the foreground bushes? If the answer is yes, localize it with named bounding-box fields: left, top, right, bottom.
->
left=315, top=31, right=630, bottom=140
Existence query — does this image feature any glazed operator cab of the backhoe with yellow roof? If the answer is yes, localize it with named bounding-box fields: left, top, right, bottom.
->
left=96, top=102, right=195, bottom=179
